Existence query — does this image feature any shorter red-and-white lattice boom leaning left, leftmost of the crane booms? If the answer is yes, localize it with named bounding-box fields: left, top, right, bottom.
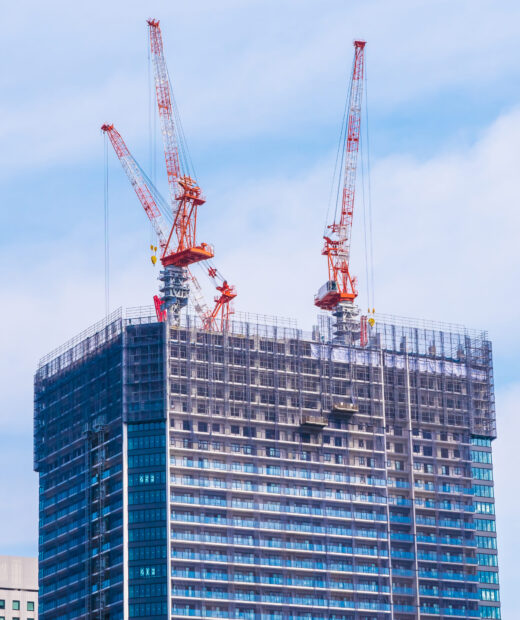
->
left=101, top=124, right=167, bottom=248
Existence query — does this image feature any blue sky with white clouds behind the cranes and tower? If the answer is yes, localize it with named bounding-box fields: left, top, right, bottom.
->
left=0, top=0, right=520, bottom=618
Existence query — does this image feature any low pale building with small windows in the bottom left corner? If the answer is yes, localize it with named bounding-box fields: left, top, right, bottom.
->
left=0, top=555, right=38, bottom=620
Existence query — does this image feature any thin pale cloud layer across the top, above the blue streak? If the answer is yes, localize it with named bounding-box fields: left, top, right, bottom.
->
left=0, top=0, right=520, bottom=174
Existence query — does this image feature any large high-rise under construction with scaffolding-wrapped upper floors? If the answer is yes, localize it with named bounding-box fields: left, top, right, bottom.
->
left=34, top=311, right=500, bottom=620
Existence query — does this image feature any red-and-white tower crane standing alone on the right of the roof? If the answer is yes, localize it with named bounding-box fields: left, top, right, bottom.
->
left=314, top=41, right=366, bottom=338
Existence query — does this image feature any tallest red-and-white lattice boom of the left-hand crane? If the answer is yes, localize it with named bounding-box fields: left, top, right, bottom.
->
left=147, top=19, right=181, bottom=204
